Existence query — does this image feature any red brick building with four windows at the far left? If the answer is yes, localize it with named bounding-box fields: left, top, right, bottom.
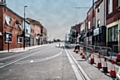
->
left=0, top=0, right=23, bottom=50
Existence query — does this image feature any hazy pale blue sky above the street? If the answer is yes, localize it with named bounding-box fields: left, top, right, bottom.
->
left=6, top=0, right=92, bottom=40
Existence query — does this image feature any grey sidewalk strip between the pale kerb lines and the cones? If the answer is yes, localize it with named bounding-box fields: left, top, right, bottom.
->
left=67, top=49, right=115, bottom=80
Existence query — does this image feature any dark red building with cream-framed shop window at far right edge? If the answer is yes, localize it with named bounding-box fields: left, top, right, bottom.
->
left=106, top=0, right=120, bottom=52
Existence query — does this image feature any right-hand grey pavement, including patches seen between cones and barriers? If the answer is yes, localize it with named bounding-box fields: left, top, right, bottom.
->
left=67, top=49, right=120, bottom=80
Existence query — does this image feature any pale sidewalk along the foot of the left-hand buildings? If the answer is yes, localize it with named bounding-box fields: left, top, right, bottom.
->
left=0, top=45, right=45, bottom=53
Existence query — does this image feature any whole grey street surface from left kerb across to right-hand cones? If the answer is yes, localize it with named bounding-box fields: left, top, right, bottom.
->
left=0, top=42, right=118, bottom=80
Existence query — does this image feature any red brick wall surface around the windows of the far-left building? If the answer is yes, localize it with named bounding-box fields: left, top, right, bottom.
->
left=2, top=8, right=23, bottom=50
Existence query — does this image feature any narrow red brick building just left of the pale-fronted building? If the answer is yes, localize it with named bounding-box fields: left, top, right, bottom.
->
left=86, top=1, right=97, bottom=45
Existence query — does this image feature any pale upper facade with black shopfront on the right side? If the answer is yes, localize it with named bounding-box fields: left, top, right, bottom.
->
left=93, top=0, right=106, bottom=46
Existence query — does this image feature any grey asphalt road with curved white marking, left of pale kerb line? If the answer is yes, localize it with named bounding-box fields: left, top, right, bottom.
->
left=0, top=44, right=78, bottom=80
